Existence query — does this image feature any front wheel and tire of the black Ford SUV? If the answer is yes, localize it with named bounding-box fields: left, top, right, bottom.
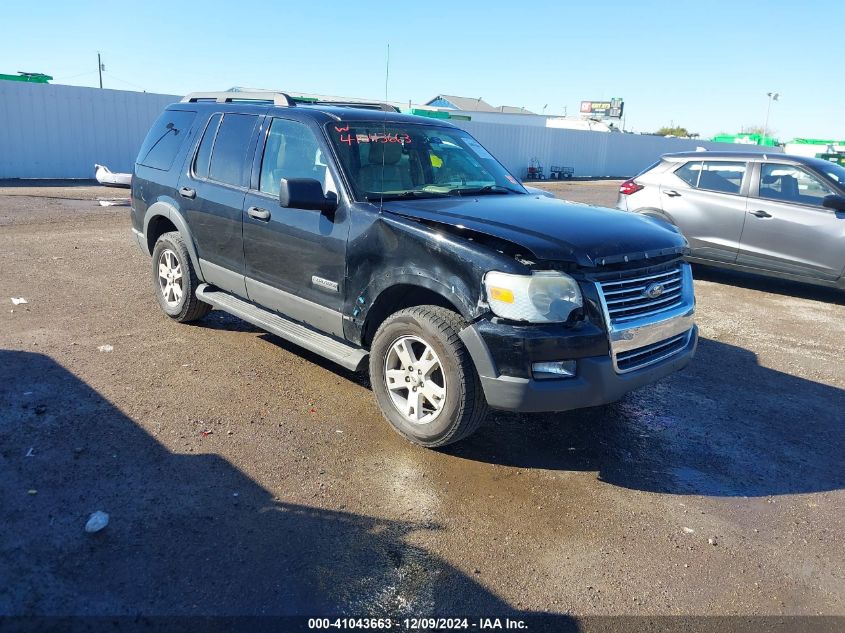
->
left=370, top=306, right=487, bottom=448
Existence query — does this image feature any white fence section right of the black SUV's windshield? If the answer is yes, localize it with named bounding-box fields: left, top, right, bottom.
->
left=453, top=121, right=782, bottom=178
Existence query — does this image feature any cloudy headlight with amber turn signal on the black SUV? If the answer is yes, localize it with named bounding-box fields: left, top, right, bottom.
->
left=484, top=270, right=583, bottom=323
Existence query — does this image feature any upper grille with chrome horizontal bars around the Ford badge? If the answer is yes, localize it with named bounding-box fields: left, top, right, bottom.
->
left=599, top=266, right=683, bottom=324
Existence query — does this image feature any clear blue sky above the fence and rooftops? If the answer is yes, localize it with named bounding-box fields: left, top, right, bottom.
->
left=0, top=0, right=845, bottom=140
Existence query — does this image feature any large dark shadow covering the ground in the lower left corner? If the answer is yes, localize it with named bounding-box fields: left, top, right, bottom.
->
left=0, top=351, right=575, bottom=630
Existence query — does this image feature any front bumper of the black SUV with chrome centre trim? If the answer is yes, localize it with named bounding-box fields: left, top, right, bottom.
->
left=460, top=264, right=698, bottom=412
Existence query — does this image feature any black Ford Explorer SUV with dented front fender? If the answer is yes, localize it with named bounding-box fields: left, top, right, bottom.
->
left=132, top=92, right=697, bottom=446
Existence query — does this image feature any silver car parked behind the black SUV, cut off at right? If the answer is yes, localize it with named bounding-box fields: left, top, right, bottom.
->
left=616, top=151, right=845, bottom=289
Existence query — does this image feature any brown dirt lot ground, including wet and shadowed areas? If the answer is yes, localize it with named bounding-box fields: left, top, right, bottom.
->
left=0, top=181, right=845, bottom=617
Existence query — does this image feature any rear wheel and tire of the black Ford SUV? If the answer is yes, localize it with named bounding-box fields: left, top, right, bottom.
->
left=153, top=231, right=211, bottom=323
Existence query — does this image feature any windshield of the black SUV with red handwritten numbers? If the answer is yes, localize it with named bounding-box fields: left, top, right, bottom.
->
left=326, top=121, right=527, bottom=201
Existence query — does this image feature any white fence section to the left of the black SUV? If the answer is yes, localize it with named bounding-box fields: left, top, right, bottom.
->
left=0, top=81, right=180, bottom=178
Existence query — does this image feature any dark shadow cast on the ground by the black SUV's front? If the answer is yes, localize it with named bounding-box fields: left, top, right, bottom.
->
left=445, top=339, right=845, bottom=496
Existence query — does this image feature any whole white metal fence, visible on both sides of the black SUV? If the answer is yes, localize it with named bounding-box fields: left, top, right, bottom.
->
left=0, top=81, right=780, bottom=178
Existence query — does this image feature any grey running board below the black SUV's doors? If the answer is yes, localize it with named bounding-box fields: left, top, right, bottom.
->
left=197, top=284, right=367, bottom=371
